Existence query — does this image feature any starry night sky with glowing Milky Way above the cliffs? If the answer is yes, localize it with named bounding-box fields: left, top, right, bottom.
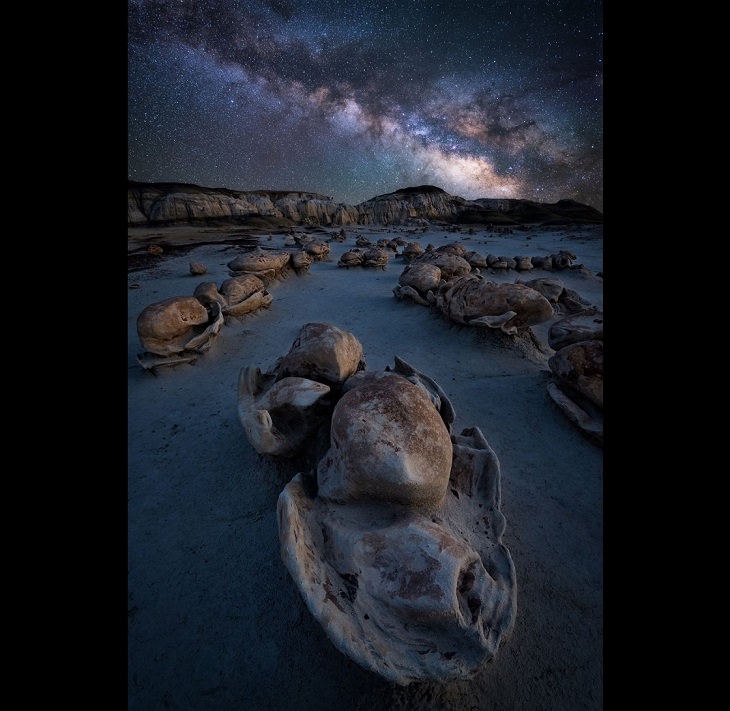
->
left=127, top=0, right=603, bottom=211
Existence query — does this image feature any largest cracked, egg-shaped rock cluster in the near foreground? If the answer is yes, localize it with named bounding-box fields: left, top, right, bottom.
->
left=239, top=324, right=517, bottom=685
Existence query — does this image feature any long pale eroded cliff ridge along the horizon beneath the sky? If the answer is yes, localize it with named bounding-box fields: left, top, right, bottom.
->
left=127, top=180, right=603, bottom=227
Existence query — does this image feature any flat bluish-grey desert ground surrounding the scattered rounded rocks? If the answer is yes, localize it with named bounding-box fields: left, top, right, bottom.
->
left=127, top=220, right=603, bottom=711
